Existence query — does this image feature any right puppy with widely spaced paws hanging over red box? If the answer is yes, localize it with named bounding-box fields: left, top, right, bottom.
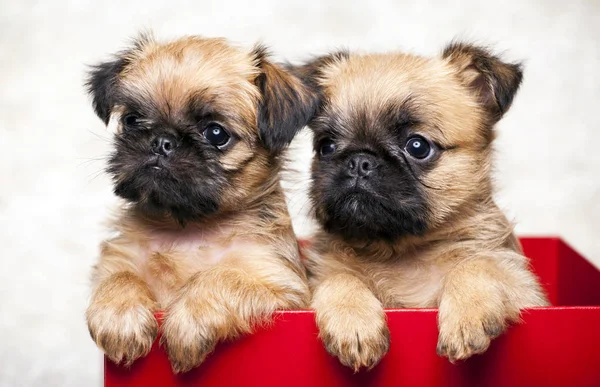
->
left=295, top=43, right=547, bottom=370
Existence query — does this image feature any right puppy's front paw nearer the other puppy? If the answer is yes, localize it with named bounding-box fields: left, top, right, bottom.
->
left=318, top=309, right=390, bottom=372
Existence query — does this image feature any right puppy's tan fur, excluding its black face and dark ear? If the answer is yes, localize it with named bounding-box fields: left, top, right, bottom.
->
left=300, top=45, right=548, bottom=370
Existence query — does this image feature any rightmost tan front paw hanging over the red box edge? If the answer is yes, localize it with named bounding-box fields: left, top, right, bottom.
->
left=437, top=310, right=506, bottom=362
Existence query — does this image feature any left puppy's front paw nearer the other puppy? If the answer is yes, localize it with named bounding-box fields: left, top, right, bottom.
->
left=160, top=300, right=229, bottom=373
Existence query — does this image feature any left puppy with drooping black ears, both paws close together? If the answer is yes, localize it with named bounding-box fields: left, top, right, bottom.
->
left=86, top=36, right=315, bottom=372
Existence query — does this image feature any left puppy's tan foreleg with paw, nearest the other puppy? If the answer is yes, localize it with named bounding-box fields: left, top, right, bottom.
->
left=162, top=252, right=309, bottom=372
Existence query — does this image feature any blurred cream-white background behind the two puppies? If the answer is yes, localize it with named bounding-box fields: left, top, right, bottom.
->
left=0, top=0, right=600, bottom=386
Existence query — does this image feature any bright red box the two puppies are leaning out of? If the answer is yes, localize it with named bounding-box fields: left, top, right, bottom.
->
left=104, top=238, right=600, bottom=387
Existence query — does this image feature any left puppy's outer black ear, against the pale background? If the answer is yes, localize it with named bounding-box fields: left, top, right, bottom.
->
left=85, top=57, right=126, bottom=125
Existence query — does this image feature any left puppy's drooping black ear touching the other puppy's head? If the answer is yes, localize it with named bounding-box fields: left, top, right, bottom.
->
left=254, top=46, right=316, bottom=153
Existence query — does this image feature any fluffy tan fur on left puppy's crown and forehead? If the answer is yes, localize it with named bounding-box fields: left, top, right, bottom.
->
left=121, top=36, right=260, bottom=141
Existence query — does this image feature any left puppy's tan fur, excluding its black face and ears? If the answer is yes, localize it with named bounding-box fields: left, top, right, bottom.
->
left=87, top=37, right=309, bottom=372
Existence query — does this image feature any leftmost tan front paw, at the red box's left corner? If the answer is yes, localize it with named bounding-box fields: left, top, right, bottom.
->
left=86, top=305, right=158, bottom=366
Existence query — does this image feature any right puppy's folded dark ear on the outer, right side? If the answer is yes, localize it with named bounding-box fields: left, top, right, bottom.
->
left=442, top=42, right=523, bottom=123
